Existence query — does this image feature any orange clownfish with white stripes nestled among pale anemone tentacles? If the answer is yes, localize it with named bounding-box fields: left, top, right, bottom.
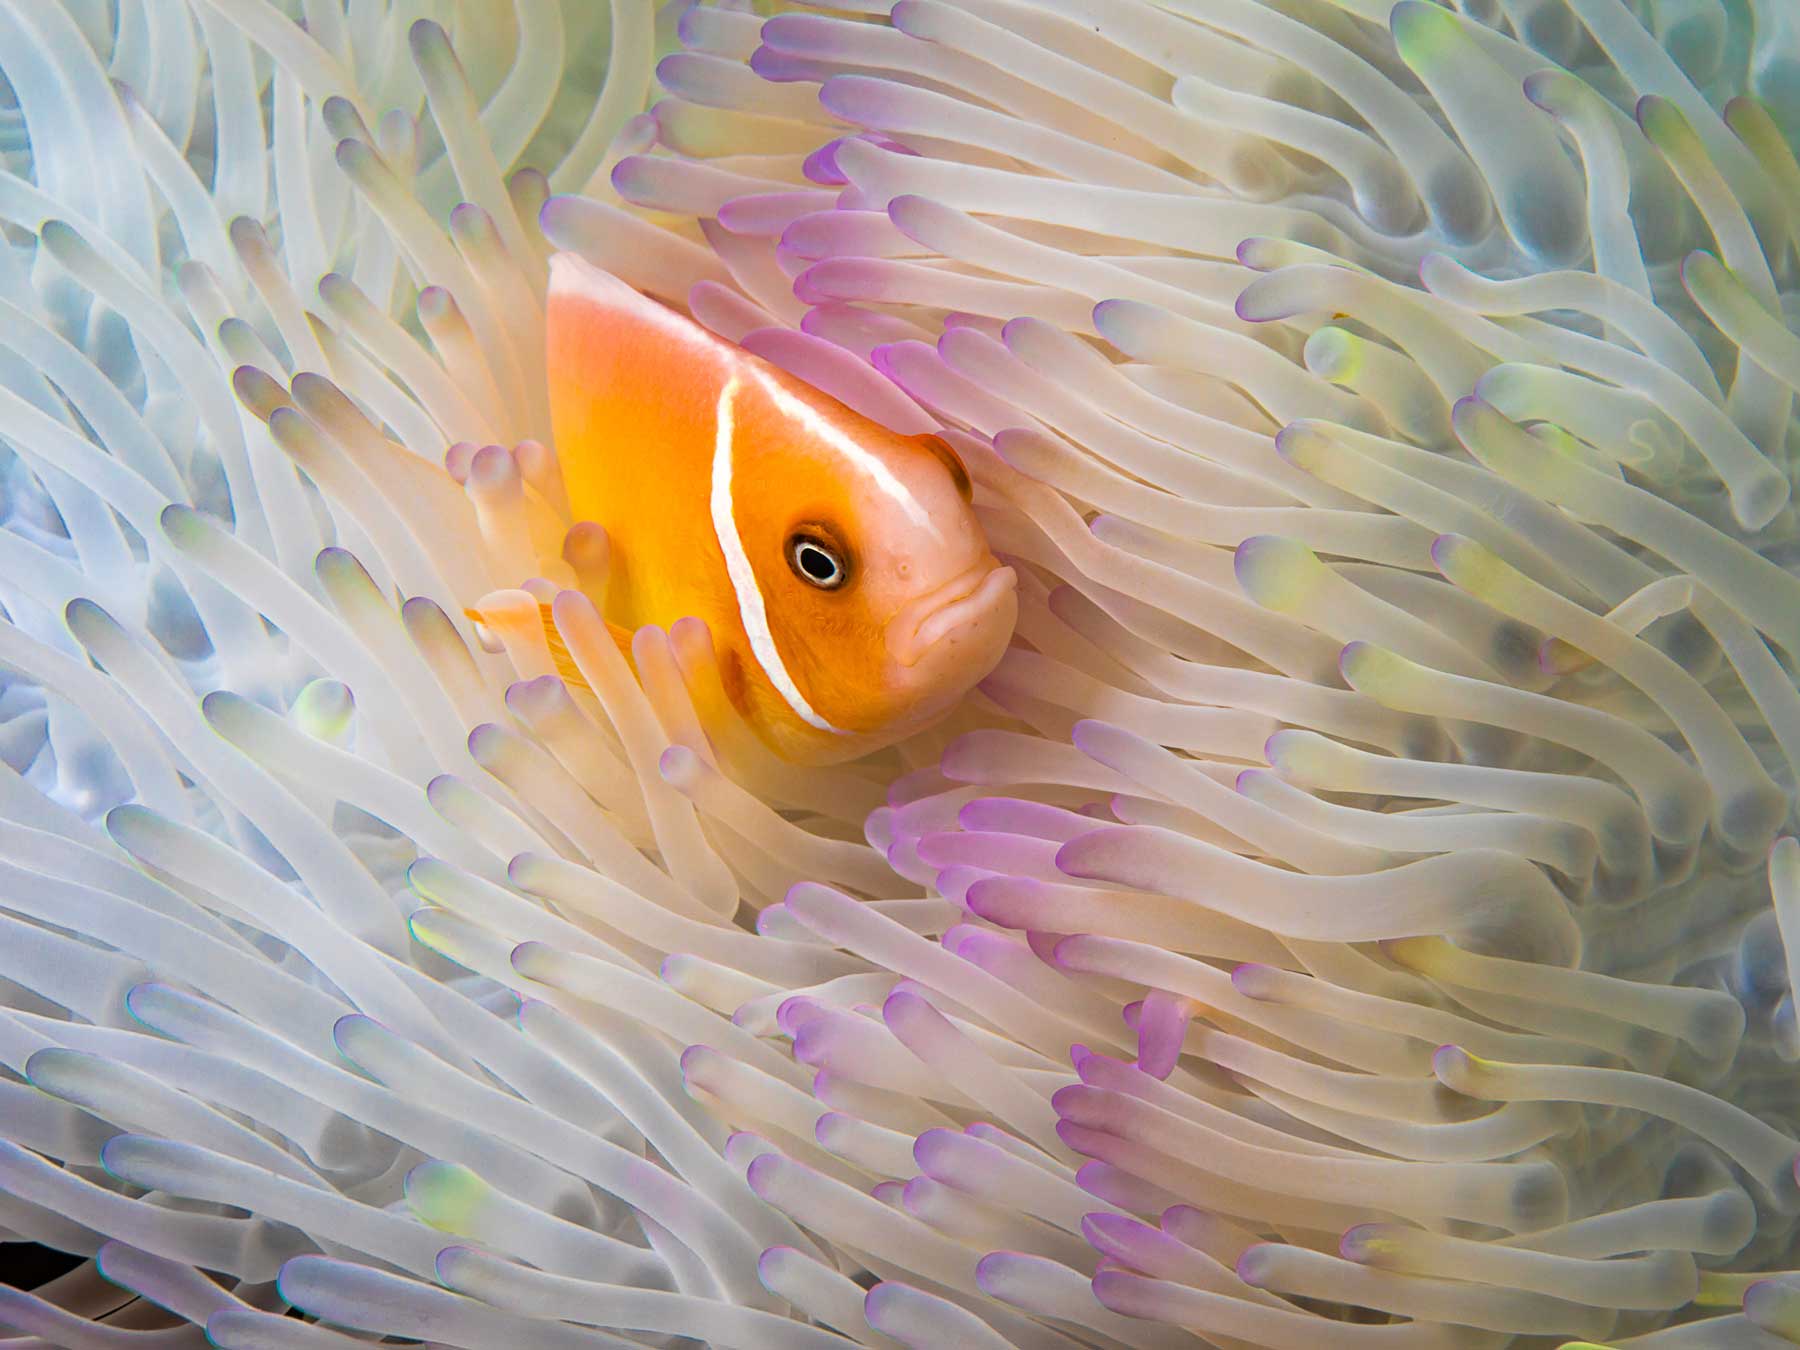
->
left=493, top=254, right=1017, bottom=763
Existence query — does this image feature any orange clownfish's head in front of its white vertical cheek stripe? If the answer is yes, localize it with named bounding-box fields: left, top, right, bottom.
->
left=733, top=369, right=1017, bottom=761
